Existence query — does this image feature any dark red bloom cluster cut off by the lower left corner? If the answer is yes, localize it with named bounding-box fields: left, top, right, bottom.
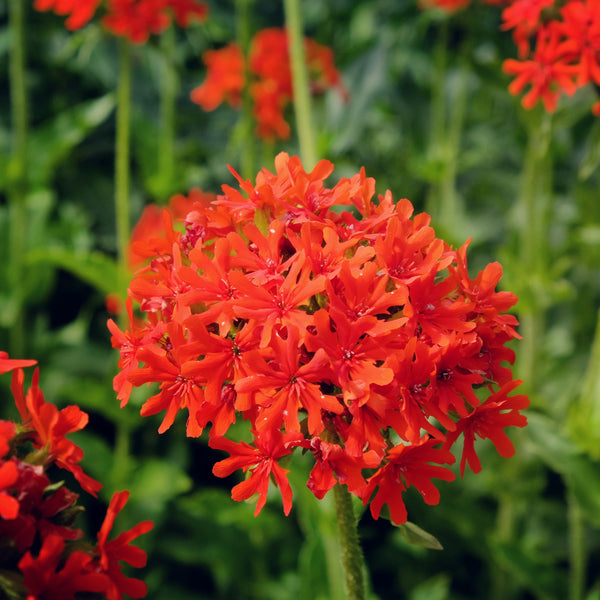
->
left=0, top=352, right=152, bottom=600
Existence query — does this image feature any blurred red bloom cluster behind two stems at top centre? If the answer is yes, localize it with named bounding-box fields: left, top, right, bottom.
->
left=191, top=28, right=346, bottom=140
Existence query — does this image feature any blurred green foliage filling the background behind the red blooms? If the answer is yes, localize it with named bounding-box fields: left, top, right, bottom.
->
left=0, top=0, right=600, bottom=600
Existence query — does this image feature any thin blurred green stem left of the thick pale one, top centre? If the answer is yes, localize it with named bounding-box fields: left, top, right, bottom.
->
left=235, top=0, right=256, bottom=179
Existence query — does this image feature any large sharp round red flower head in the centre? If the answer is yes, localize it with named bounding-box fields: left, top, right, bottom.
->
left=108, top=153, right=528, bottom=523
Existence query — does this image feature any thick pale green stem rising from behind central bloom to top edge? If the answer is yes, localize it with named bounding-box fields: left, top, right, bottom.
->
left=284, top=0, right=317, bottom=170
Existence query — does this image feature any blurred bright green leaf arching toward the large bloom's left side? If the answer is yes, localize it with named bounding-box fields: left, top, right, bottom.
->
left=25, top=247, right=119, bottom=295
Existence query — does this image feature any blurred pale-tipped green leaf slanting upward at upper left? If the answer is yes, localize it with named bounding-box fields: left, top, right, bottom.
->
left=28, top=94, right=115, bottom=187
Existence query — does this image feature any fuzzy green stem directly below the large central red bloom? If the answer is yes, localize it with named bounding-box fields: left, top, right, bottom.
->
left=333, top=483, right=366, bottom=600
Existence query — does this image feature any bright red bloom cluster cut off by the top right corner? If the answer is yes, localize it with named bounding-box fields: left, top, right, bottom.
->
left=428, top=0, right=600, bottom=115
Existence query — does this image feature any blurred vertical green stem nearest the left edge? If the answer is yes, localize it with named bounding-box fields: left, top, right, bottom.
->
left=7, top=0, right=29, bottom=356
